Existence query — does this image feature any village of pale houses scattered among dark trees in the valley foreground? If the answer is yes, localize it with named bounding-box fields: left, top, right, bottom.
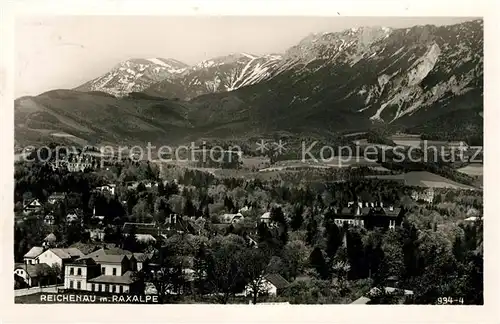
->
left=14, top=144, right=482, bottom=304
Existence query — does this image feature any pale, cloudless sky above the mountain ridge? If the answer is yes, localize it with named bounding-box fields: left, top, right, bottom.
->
left=15, top=16, right=474, bottom=98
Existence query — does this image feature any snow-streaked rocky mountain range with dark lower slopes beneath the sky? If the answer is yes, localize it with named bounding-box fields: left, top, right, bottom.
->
left=15, top=20, right=484, bottom=145
